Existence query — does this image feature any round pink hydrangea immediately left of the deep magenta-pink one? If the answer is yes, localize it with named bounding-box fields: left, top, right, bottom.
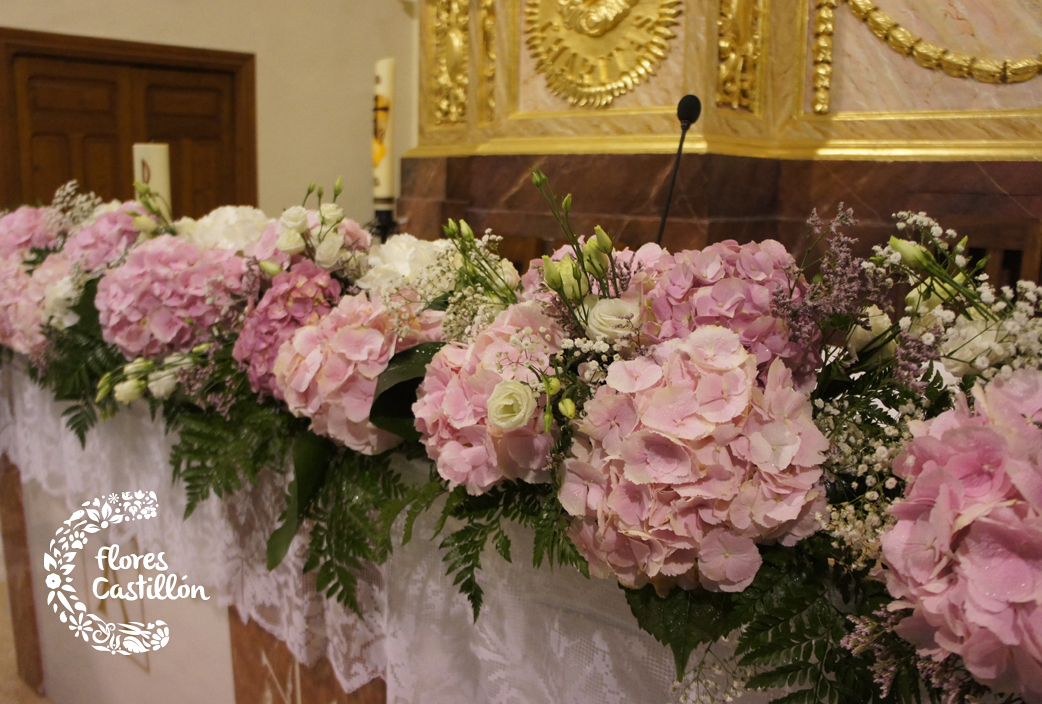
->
left=95, top=234, right=248, bottom=359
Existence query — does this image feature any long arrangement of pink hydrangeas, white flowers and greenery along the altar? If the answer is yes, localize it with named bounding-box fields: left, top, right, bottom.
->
left=0, top=172, right=1042, bottom=704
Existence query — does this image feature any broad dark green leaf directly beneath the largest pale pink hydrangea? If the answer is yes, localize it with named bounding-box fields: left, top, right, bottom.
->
left=622, top=584, right=731, bottom=679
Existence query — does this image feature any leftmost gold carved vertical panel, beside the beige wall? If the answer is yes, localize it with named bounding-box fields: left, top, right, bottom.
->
left=429, top=0, right=470, bottom=125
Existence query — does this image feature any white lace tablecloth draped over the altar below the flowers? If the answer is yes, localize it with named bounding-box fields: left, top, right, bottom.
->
left=0, top=360, right=754, bottom=704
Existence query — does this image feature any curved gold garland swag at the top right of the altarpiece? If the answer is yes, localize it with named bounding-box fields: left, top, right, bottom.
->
left=848, top=0, right=1042, bottom=88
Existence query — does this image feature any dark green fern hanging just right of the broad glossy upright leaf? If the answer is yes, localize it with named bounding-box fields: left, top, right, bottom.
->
left=301, top=450, right=408, bottom=617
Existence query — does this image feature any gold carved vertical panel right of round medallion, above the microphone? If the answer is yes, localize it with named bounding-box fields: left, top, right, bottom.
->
left=716, top=0, right=767, bottom=115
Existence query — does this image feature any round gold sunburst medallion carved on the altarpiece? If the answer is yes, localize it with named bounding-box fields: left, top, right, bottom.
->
left=525, top=0, right=680, bottom=107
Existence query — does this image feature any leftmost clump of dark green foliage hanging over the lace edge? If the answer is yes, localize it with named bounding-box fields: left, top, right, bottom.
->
left=30, top=279, right=126, bottom=445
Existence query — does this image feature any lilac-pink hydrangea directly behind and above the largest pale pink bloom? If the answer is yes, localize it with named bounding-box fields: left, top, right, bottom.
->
left=643, top=240, right=821, bottom=391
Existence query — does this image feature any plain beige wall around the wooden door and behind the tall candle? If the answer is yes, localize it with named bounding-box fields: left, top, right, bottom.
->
left=0, top=0, right=419, bottom=222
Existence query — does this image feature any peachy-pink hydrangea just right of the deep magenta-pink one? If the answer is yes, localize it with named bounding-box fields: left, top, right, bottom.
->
left=274, top=293, right=401, bottom=455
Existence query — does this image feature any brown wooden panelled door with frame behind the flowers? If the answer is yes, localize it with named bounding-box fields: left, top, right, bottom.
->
left=0, top=29, right=256, bottom=218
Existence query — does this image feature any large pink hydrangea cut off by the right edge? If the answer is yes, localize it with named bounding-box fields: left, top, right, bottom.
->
left=883, top=370, right=1042, bottom=702
